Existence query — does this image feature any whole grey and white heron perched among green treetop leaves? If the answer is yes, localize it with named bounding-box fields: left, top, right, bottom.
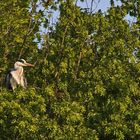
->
left=5, top=59, right=34, bottom=91
